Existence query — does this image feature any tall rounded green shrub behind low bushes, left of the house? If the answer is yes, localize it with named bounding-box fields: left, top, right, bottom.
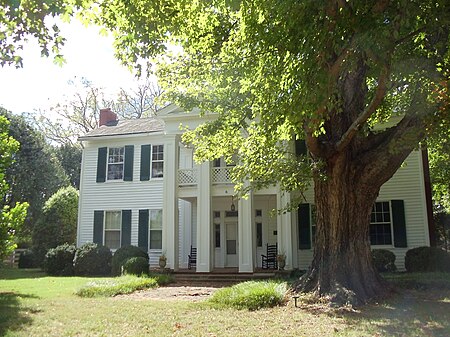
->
left=33, top=186, right=78, bottom=263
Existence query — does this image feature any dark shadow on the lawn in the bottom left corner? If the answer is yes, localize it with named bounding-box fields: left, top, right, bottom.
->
left=0, top=292, right=39, bottom=336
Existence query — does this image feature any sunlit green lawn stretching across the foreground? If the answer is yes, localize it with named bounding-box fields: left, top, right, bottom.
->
left=0, top=269, right=450, bottom=337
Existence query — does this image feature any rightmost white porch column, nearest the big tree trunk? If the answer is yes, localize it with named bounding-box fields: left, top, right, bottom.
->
left=277, top=191, right=294, bottom=270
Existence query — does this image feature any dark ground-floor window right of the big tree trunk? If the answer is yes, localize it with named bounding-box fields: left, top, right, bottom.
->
left=370, top=201, right=392, bottom=245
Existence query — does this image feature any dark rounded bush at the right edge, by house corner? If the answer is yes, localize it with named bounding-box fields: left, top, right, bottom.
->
left=405, top=247, right=450, bottom=272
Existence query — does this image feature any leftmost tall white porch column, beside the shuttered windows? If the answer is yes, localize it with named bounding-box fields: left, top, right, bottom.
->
left=162, top=135, right=179, bottom=270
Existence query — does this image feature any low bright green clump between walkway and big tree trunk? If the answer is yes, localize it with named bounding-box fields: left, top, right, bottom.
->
left=209, top=281, right=287, bottom=310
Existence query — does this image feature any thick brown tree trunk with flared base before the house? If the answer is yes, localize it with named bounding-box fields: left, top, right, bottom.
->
left=297, top=152, right=389, bottom=305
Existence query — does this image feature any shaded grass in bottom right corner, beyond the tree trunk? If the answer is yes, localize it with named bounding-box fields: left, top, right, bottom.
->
left=342, top=289, right=450, bottom=337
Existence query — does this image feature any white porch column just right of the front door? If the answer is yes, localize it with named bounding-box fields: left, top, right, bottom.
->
left=238, top=192, right=254, bottom=273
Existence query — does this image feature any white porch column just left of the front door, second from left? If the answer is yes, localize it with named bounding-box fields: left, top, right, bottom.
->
left=197, top=162, right=213, bottom=272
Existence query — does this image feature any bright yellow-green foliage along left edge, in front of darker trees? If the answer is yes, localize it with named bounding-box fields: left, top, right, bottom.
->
left=0, top=111, right=28, bottom=258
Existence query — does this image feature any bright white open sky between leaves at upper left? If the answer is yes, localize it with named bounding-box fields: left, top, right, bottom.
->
left=0, top=20, right=137, bottom=113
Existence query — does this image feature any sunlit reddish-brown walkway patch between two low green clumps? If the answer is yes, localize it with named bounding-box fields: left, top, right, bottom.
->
left=115, top=285, right=218, bottom=302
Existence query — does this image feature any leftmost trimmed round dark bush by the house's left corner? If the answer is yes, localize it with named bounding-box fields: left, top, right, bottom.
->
left=44, top=243, right=77, bottom=276
